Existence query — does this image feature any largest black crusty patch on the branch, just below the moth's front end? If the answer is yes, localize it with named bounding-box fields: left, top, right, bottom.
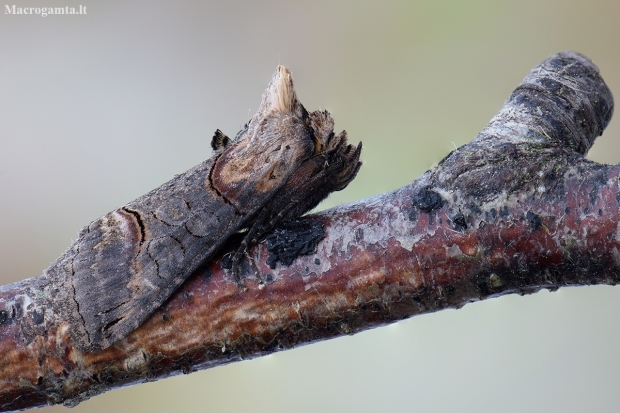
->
left=265, top=219, right=325, bottom=269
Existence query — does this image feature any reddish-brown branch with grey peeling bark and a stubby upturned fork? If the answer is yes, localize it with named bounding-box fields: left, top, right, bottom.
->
left=0, top=52, right=620, bottom=411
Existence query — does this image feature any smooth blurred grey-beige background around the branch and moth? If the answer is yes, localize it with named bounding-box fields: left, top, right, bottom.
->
left=0, top=0, right=620, bottom=413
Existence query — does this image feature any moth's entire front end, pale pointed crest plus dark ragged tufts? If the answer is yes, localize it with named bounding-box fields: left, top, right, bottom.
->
left=209, top=66, right=362, bottom=214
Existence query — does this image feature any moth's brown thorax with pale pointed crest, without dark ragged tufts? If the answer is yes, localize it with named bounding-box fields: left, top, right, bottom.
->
left=211, top=66, right=315, bottom=211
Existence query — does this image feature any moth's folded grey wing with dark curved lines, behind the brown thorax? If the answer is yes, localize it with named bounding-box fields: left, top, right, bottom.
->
left=63, top=142, right=310, bottom=351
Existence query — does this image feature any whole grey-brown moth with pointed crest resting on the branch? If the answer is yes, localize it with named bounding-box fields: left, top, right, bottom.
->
left=46, top=66, right=362, bottom=351
